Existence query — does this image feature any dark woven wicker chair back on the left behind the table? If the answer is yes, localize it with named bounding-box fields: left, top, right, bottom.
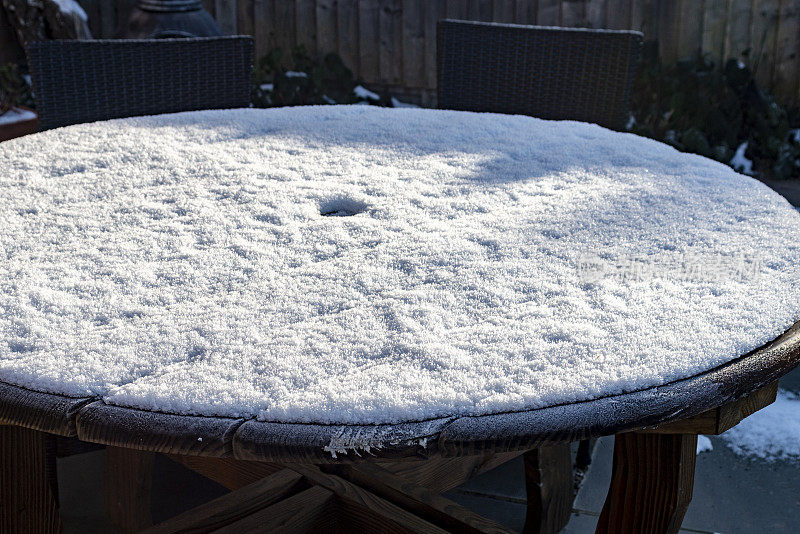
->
left=27, top=36, right=253, bottom=130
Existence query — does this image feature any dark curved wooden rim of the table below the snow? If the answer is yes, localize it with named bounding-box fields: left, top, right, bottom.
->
left=0, top=321, right=800, bottom=463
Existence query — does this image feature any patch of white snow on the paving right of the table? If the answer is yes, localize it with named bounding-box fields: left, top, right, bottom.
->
left=721, top=390, right=800, bottom=461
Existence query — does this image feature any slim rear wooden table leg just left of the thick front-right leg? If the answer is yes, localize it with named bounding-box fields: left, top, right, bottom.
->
left=522, top=443, right=575, bottom=534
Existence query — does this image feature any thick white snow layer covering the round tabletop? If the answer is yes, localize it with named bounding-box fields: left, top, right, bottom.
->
left=0, top=106, right=800, bottom=423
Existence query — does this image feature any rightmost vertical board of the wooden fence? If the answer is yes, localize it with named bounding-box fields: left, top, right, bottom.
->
left=772, top=0, right=800, bottom=105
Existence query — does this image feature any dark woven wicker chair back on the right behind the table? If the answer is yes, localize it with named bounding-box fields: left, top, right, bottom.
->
left=438, top=20, right=642, bottom=129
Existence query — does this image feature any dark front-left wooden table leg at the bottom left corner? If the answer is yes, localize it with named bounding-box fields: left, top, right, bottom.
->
left=0, top=426, right=61, bottom=534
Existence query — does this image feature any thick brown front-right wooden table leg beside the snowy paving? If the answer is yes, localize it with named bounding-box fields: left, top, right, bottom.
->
left=597, top=432, right=697, bottom=534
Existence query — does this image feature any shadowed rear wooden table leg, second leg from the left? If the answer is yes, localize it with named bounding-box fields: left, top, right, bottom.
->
left=103, top=447, right=155, bottom=532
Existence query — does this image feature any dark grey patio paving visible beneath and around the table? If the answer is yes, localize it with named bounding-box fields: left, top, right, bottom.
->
left=58, top=184, right=800, bottom=534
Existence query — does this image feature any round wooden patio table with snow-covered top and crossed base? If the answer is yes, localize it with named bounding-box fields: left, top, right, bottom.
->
left=0, top=106, right=800, bottom=532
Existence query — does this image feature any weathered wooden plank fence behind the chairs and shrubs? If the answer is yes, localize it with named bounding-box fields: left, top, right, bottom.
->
left=6, top=0, right=800, bottom=105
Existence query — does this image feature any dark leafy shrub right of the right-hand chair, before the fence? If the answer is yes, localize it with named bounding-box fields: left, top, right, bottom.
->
left=631, top=43, right=800, bottom=179
